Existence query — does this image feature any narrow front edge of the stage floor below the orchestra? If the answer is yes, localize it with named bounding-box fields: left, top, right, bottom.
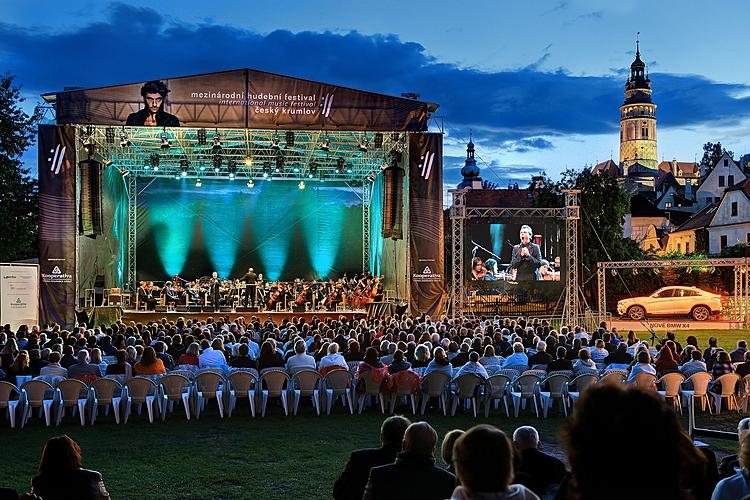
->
left=121, top=309, right=367, bottom=324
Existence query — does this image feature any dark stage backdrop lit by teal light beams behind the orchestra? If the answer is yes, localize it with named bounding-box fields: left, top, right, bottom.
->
left=137, top=179, right=362, bottom=281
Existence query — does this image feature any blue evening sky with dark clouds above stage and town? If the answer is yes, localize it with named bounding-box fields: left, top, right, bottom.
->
left=0, top=0, right=750, bottom=188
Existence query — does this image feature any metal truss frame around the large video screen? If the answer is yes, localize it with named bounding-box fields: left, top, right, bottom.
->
left=450, top=188, right=584, bottom=325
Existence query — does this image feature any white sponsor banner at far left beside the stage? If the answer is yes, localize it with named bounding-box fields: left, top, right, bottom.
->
left=0, top=264, right=39, bottom=331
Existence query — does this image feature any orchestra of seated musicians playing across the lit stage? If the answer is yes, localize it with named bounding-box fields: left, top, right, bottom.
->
left=137, top=268, right=383, bottom=312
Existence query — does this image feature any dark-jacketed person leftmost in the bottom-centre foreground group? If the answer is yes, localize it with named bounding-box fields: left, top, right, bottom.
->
left=333, top=415, right=411, bottom=500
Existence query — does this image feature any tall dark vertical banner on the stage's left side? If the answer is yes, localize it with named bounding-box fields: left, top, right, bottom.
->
left=39, top=125, right=77, bottom=328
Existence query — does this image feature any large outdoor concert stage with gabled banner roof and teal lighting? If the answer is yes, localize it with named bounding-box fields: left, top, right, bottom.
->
left=38, top=69, right=446, bottom=328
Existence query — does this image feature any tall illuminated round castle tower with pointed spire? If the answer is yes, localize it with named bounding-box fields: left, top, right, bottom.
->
left=620, top=36, right=659, bottom=176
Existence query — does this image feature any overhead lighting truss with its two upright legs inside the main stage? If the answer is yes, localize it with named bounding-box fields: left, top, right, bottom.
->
left=75, top=125, right=408, bottom=293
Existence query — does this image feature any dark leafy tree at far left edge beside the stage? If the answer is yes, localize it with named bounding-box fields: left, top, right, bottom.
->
left=0, top=75, right=38, bottom=262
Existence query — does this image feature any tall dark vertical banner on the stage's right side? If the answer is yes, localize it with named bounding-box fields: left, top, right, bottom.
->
left=409, top=134, right=445, bottom=317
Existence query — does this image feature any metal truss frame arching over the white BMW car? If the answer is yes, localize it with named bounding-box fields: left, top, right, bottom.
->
left=597, top=258, right=750, bottom=323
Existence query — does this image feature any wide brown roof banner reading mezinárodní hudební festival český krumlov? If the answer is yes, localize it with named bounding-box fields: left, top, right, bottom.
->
left=50, top=69, right=437, bottom=131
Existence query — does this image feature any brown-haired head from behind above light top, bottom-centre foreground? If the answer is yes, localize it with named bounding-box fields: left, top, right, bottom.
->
left=453, top=424, right=513, bottom=494
